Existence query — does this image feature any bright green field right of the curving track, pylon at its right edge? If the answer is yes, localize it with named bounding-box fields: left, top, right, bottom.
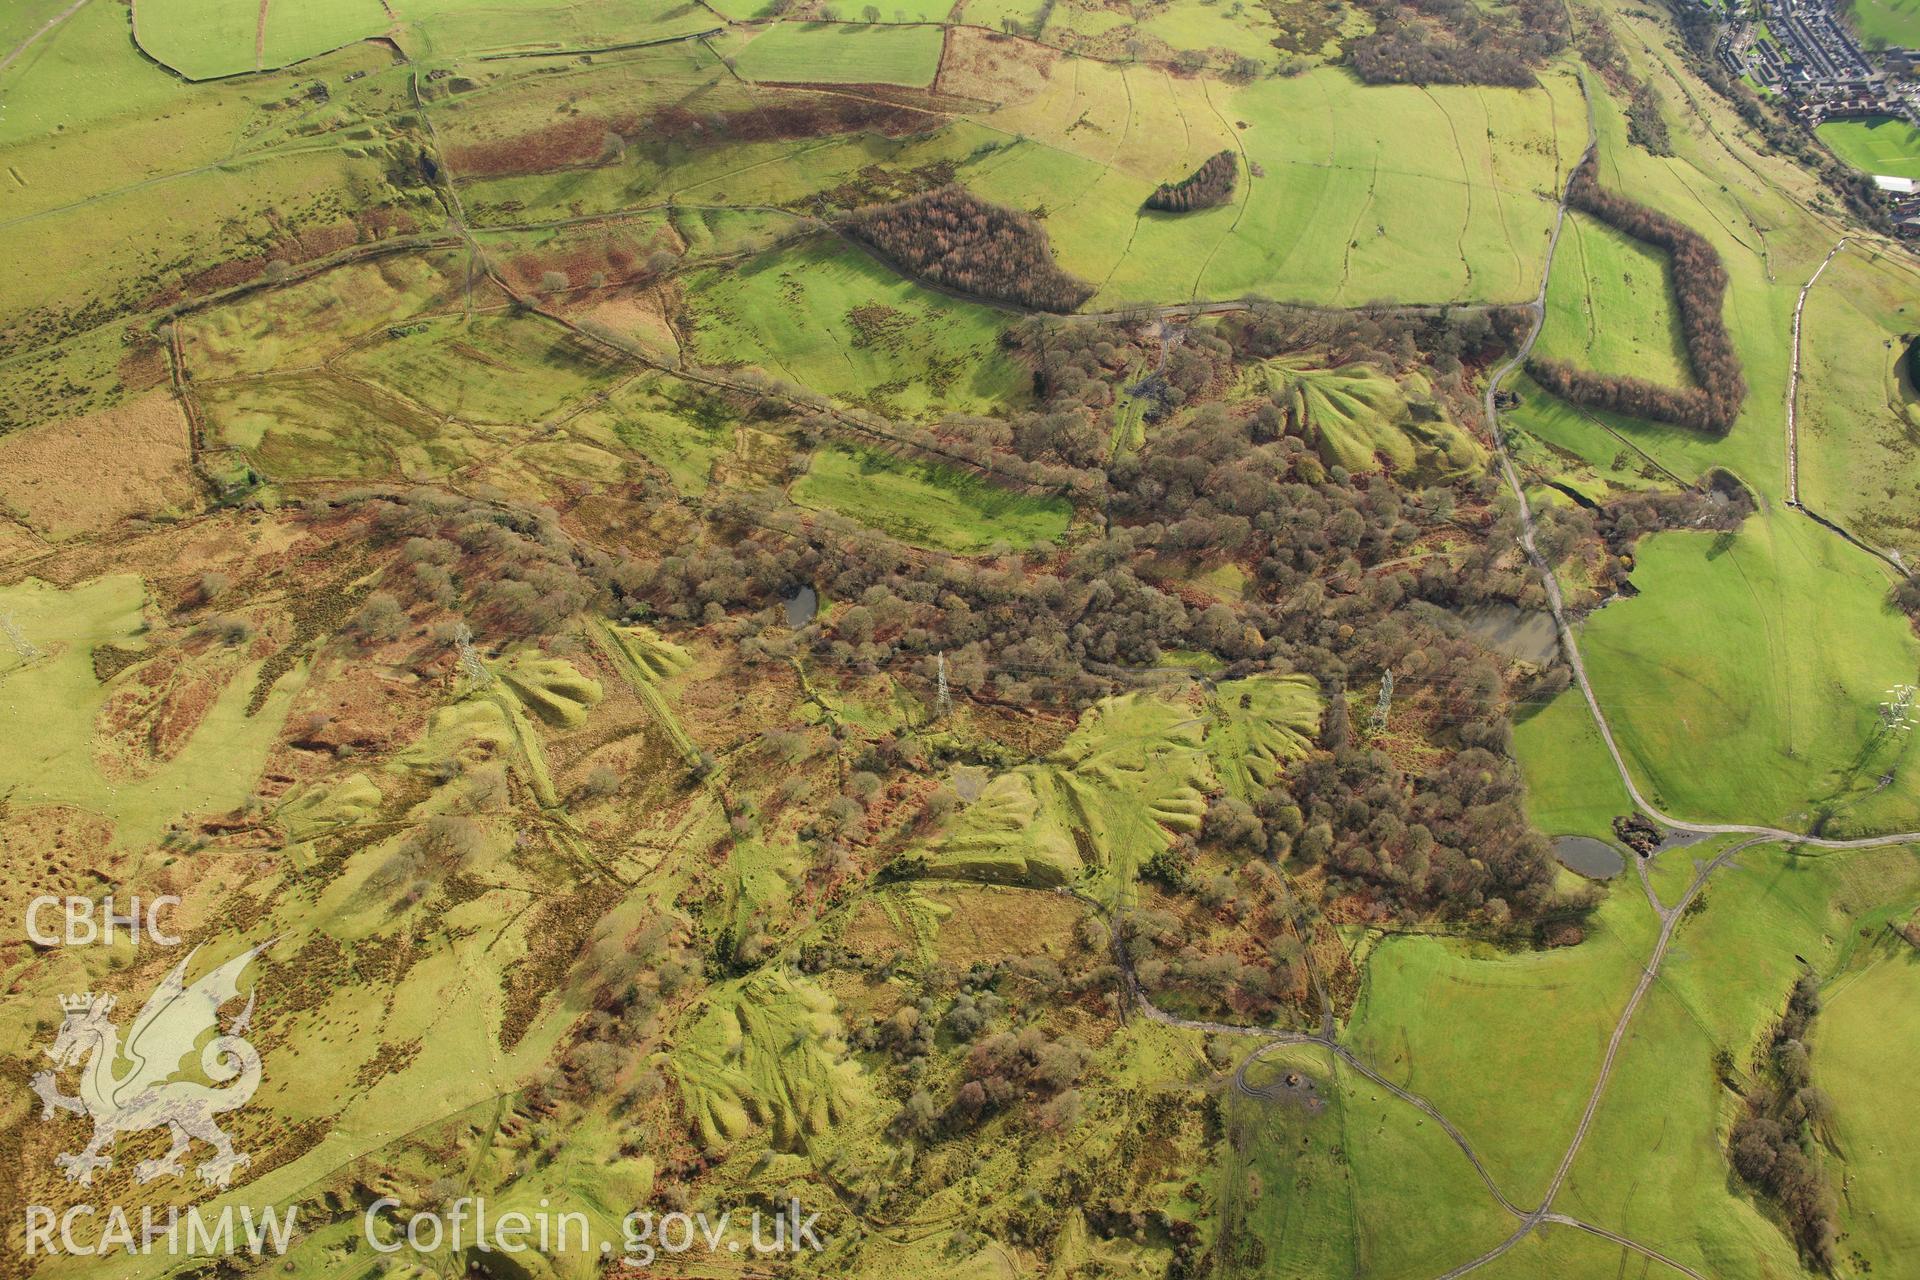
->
left=1580, top=509, right=1920, bottom=835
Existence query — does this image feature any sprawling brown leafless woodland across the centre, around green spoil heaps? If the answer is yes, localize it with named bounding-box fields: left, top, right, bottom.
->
left=309, top=293, right=1758, bottom=990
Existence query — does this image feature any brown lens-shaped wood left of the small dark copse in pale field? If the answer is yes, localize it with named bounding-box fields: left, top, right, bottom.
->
left=845, top=184, right=1092, bottom=311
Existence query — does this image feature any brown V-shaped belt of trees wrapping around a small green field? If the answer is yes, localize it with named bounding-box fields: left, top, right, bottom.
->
left=1526, top=155, right=1747, bottom=436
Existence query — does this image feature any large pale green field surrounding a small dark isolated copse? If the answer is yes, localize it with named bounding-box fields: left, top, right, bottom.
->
left=964, top=61, right=1578, bottom=309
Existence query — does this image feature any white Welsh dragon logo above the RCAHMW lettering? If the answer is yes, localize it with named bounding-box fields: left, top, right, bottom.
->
left=33, top=946, right=261, bottom=1188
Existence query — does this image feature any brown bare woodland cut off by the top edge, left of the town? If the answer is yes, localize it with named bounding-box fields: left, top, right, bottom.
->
left=1346, top=0, right=1572, bottom=88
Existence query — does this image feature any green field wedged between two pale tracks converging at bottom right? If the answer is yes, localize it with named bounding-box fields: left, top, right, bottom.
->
left=1346, top=871, right=1657, bottom=1205
